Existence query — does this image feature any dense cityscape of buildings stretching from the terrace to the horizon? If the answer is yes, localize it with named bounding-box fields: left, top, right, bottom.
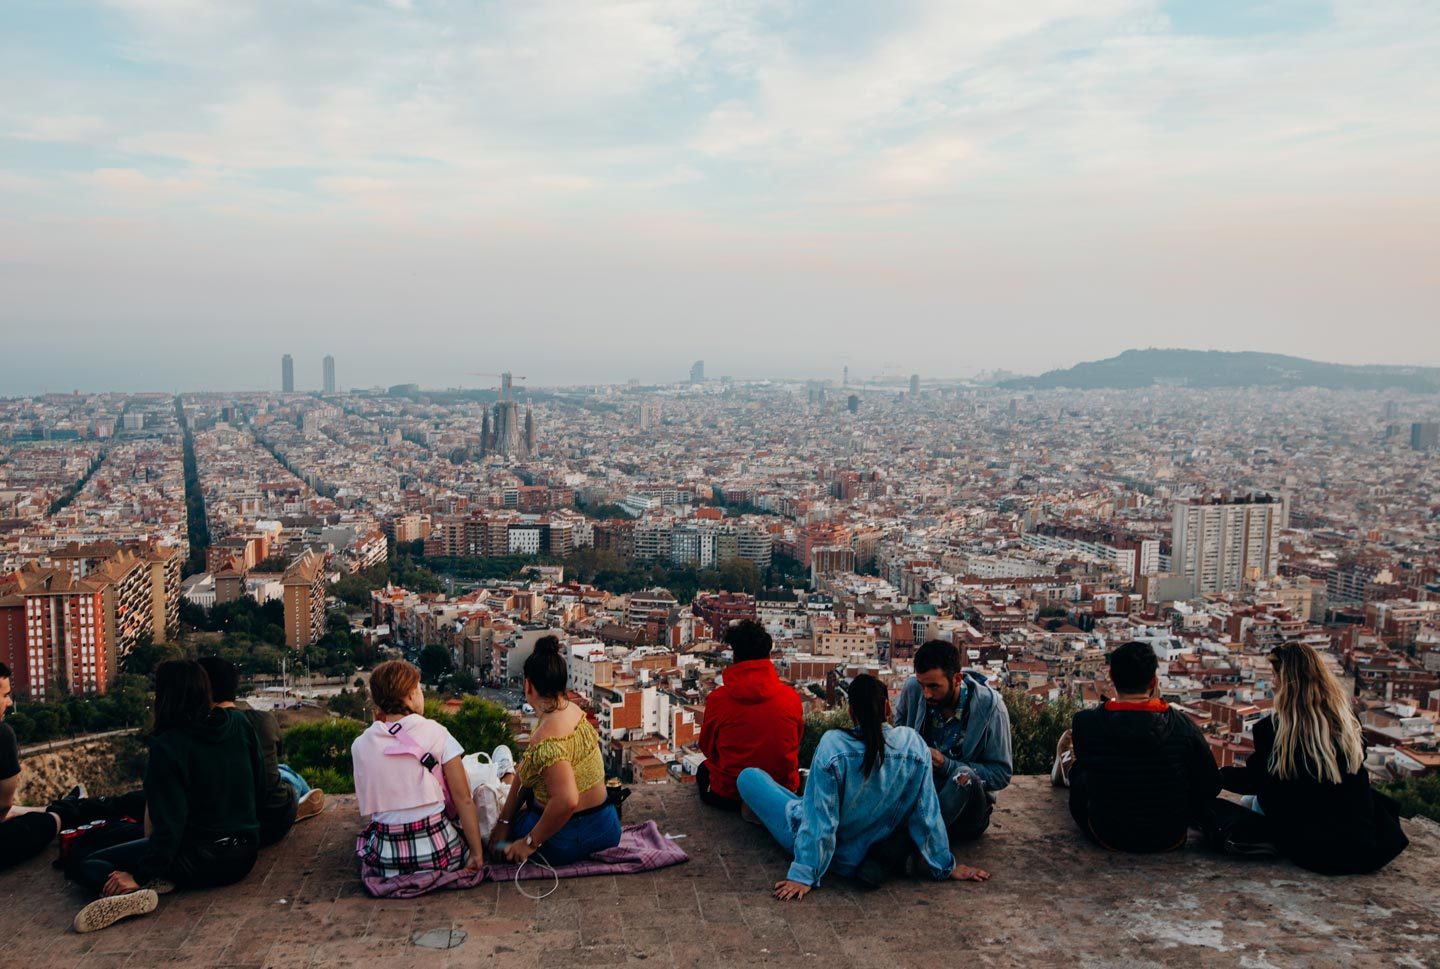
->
left=8, top=356, right=1440, bottom=800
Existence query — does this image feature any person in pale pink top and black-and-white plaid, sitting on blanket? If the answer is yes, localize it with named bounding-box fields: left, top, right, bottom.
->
left=350, top=659, right=485, bottom=878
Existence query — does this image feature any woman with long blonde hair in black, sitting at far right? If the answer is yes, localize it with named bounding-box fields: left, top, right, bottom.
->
left=1221, top=642, right=1410, bottom=875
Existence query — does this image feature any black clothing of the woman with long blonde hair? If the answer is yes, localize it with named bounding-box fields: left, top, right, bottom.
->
left=1224, top=717, right=1410, bottom=875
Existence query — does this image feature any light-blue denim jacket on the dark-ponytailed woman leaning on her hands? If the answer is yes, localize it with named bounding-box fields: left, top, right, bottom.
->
left=788, top=726, right=955, bottom=887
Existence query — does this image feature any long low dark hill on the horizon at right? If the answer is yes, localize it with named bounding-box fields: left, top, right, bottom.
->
left=996, top=348, right=1440, bottom=393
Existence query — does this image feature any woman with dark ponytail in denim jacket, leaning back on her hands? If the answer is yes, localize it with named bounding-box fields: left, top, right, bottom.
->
left=739, top=674, right=989, bottom=900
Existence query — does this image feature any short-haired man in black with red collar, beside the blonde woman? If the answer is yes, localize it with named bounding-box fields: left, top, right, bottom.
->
left=1061, top=642, right=1220, bottom=852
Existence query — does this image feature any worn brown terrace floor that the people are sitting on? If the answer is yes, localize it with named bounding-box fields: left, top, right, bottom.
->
left=0, top=778, right=1440, bottom=969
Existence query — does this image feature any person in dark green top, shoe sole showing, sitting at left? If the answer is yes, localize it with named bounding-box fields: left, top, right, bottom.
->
left=75, top=659, right=264, bottom=932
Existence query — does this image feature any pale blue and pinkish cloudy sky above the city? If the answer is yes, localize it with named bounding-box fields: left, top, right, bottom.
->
left=0, top=0, right=1440, bottom=396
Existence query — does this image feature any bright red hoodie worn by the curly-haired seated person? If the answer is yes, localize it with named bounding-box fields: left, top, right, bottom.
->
left=700, top=659, right=805, bottom=798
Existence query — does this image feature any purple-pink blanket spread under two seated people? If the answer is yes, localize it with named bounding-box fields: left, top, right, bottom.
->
left=360, top=821, right=690, bottom=898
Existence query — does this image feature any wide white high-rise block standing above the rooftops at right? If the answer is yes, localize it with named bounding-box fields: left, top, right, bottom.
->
left=1171, top=495, right=1280, bottom=596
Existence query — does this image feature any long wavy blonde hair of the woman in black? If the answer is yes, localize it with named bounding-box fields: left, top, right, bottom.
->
left=1270, top=642, right=1365, bottom=783
